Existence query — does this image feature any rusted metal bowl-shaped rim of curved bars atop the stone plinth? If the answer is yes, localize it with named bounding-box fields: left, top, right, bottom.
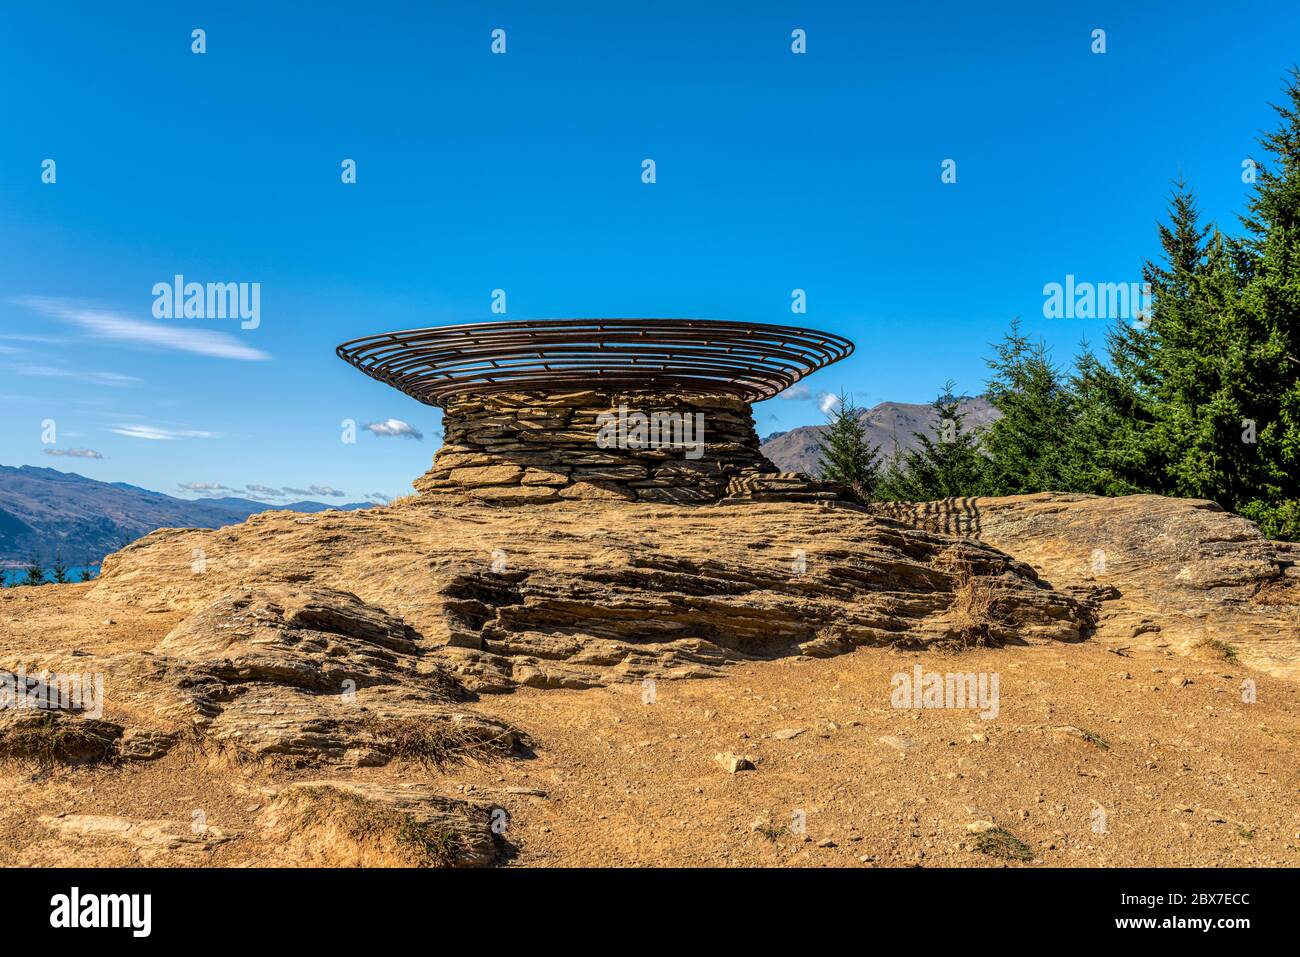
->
left=337, top=319, right=853, bottom=406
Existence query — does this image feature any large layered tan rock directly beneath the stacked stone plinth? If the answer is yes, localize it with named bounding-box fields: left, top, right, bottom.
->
left=86, top=498, right=1089, bottom=691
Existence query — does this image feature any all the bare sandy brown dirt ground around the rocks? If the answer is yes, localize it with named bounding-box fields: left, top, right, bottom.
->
left=0, top=585, right=1300, bottom=866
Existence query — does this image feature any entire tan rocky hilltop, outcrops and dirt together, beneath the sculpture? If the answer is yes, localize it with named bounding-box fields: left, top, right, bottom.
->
left=0, top=485, right=1300, bottom=866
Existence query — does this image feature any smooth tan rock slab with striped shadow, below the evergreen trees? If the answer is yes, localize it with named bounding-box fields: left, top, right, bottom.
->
left=876, top=493, right=1300, bottom=679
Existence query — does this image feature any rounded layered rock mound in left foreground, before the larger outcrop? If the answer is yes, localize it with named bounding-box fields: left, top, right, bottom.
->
left=143, top=586, right=517, bottom=766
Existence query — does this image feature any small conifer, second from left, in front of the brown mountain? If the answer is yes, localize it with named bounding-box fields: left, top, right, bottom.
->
left=878, top=380, right=988, bottom=502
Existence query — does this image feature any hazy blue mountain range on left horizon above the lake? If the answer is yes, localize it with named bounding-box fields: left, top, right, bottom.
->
left=0, top=465, right=369, bottom=568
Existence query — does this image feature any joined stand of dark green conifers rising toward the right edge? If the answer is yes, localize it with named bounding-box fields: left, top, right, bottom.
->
left=878, top=70, right=1300, bottom=540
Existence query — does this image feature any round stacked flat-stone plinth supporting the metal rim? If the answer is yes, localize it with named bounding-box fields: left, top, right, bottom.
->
left=415, top=390, right=842, bottom=505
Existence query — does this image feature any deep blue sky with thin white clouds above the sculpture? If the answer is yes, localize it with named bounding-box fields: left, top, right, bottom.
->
left=0, top=0, right=1300, bottom=501
